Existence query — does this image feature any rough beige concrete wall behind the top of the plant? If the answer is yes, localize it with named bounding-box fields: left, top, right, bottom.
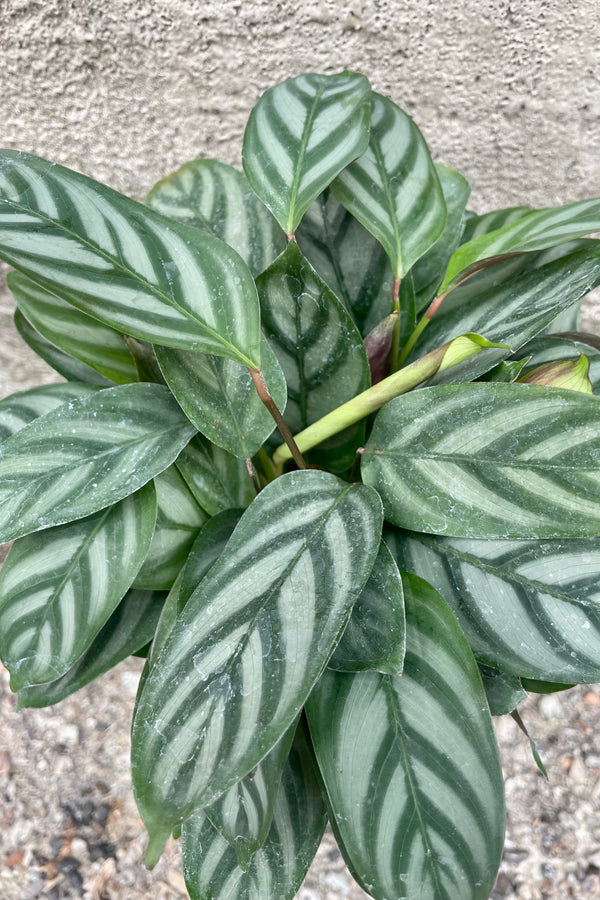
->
left=0, top=0, right=600, bottom=210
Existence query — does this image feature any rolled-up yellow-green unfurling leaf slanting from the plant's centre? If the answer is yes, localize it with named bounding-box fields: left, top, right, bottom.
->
left=273, top=335, right=509, bottom=465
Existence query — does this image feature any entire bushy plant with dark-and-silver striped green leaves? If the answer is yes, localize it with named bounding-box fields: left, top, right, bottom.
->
left=0, top=72, right=600, bottom=900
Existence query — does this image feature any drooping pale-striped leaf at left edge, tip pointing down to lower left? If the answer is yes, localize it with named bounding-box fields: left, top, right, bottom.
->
left=0, top=485, right=156, bottom=691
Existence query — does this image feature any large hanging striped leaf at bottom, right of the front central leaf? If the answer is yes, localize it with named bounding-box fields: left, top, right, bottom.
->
left=307, top=575, right=504, bottom=900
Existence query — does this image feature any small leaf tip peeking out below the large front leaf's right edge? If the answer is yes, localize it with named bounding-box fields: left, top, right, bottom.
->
left=202, top=721, right=298, bottom=872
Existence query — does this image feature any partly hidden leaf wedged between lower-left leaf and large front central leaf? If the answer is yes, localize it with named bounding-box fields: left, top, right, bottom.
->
left=133, top=466, right=208, bottom=591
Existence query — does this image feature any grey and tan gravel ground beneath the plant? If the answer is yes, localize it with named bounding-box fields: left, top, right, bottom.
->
left=0, top=284, right=600, bottom=900
